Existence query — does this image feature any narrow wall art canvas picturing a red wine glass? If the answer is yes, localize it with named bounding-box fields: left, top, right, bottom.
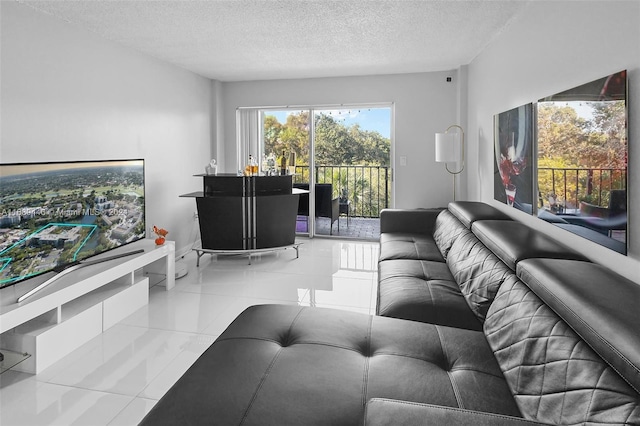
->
left=494, top=103, right=535, bottom=214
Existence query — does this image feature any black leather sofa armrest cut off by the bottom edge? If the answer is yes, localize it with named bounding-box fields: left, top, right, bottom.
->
left=364, top=398, right=542, bottom=426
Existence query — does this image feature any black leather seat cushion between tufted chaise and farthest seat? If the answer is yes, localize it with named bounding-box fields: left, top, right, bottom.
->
left=376, top=259, right=482, bottom=330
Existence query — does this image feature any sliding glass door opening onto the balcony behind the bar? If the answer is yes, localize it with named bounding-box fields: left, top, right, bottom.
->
left=259, top=105, right=393, bottom=238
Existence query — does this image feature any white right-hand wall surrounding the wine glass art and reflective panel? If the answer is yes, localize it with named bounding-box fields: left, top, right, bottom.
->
left=467, top=1, right=640, bottom=281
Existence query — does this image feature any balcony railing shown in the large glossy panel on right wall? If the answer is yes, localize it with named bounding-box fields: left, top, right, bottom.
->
left=538, top=167, right=627, bottom=209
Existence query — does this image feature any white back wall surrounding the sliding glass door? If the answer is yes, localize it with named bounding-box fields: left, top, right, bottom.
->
left=218, top=71, right=458, bottom=208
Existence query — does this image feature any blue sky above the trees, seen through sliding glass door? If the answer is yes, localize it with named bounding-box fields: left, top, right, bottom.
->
left=265, top=107, right=391, bottom=138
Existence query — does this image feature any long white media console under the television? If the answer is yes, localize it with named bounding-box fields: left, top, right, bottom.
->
left=0, top=239, right=175, bottom=374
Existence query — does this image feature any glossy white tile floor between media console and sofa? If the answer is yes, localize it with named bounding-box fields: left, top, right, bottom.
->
left=0, top=238, right=378, bottom=426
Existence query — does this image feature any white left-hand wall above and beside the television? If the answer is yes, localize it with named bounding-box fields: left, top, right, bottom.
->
left=0, top=1, right=212, bottom=252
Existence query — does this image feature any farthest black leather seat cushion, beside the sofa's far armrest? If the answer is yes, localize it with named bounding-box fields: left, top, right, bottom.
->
left=379, top=232, right=444, bottom=262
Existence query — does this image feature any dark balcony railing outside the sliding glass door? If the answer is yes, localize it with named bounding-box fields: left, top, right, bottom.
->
left=294, top=165, right=391, bottom=217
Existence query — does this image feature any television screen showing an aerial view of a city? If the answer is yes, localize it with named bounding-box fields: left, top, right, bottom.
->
left=0, top=160, right=145, bottom=288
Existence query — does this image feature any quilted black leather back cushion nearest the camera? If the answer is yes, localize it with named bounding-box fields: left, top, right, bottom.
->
left=484, top=280, right=640, bottom=425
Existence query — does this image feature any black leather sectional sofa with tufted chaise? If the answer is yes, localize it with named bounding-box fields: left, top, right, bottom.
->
left=142, top=202, right=640, bottom=425
